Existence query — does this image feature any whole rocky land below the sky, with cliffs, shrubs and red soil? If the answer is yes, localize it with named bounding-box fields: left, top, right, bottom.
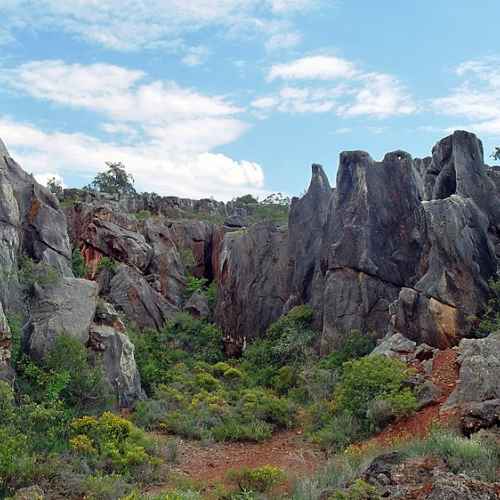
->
left=0, top=131, right=500, bottom=500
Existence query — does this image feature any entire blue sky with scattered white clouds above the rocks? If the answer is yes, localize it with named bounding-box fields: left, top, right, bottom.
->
left=0, top=0, right=500, bottom=200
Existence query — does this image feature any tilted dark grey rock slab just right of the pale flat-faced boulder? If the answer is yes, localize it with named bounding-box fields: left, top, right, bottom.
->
left=107, top=264, right=178, bottom=328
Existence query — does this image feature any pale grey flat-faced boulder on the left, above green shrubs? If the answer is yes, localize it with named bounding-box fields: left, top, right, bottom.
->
left=23, top=278, right=97, bottom=359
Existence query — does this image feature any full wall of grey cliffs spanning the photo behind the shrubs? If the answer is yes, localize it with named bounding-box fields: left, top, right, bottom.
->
left=0, top=132, right=500, bottom=386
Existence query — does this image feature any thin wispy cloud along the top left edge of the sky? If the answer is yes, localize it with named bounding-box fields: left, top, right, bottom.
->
left=2, top=0, right=317, bottom=50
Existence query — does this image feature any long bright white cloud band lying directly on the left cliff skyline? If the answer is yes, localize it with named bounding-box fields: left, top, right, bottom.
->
left=0, top=118, right=266, bottom=200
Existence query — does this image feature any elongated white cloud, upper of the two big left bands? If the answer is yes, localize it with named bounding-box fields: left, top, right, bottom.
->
left=4, top=60, right=241, bottom=122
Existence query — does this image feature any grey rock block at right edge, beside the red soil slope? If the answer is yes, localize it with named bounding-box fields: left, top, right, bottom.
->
left=446, top=334, right=500, bottom=407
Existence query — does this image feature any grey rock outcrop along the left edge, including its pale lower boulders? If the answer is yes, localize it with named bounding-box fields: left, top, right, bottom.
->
left=0, top=141, right=143, bottom=405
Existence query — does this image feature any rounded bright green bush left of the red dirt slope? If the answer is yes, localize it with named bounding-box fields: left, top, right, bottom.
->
left=335, top=356, right=417, bottom=431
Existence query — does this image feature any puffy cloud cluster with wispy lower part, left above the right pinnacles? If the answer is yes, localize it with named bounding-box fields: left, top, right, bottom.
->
left=252, top=55, right=417, bottom=118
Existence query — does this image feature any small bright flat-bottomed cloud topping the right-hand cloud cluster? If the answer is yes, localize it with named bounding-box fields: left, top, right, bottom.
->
left=267, top=55, right=357, bottom=81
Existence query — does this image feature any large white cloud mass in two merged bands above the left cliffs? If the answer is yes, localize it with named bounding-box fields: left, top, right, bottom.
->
left=0, top=61, right=270, bottom=199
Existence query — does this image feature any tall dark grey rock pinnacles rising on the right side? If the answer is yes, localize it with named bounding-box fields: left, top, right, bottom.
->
left=217, top=131, right=500, bottom=353
